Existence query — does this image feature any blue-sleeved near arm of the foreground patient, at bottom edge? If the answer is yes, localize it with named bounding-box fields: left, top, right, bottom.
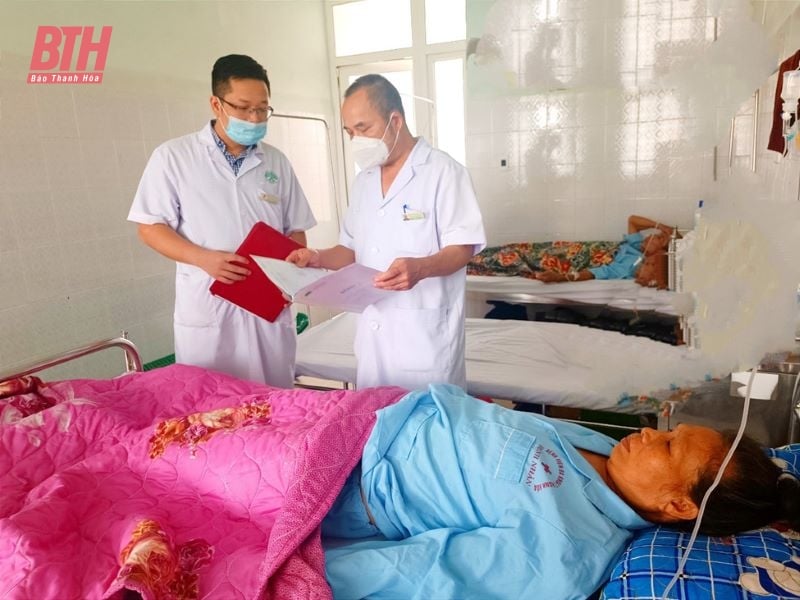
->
left=325, top=510, right=627, bottom=600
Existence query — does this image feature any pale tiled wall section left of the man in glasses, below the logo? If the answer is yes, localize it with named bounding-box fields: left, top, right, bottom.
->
left=0, top=55, right=207, bottom=375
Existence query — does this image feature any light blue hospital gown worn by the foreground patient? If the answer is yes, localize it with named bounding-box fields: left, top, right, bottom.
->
left=326, top=385, right=648, bottom=600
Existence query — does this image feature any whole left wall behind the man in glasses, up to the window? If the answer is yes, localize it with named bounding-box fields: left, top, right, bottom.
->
left=0, top=2, right=336, bottom=377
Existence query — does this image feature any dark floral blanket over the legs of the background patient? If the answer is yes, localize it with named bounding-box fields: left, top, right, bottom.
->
left=467, top=241, right=621, bottom=279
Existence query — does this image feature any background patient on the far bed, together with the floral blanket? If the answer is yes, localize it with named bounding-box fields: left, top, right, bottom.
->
left=467, top=215, right=673, bottom=289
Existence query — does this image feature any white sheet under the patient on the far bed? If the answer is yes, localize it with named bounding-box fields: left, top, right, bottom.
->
left=467, top=275, right=685, bottom=316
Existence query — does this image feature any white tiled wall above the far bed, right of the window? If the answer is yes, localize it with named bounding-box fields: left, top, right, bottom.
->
left=467, top=0, right=798, bottom=243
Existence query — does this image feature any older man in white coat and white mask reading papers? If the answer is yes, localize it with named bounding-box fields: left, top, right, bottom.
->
left=287, top=75, right=486, bottom=389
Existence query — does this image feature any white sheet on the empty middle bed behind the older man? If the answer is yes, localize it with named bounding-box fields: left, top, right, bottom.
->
left=296, top=313, right=707, bottom=413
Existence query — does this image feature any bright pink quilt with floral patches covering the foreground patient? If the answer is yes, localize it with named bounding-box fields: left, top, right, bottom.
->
left=0, top=365, right=405, bottom=600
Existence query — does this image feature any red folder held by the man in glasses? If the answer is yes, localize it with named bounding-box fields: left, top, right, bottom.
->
left=209, top=221, right=303, bottom=321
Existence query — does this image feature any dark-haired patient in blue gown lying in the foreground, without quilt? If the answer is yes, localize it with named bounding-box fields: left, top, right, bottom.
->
left=323, top=386, right=797, bottom=599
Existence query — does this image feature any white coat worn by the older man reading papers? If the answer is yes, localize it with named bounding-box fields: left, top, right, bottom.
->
left=339, top=138, right=486, bottom=389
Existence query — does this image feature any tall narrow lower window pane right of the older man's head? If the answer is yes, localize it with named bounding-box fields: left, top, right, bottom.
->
left=433, top=58, right=465, bottom=165
